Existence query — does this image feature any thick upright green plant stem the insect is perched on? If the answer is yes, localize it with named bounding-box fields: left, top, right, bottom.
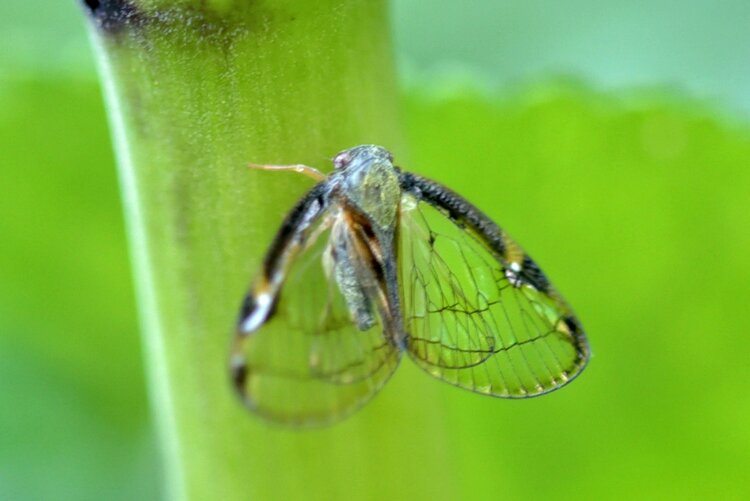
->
left=81, top=0, right=458, bottom=500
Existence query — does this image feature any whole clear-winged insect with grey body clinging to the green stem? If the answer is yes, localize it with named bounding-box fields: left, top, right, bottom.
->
left=230, top=145, right=590, bottom=426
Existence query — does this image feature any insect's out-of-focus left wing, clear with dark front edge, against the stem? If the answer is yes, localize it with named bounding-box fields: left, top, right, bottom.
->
left=232, top=189, right=399, bottom=426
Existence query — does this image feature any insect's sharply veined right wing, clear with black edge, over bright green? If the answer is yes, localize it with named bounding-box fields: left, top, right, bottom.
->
left=399, top=172, right=590, bottom=398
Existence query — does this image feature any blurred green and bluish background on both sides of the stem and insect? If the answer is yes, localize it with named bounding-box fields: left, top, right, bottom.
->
left=0, top=0, right=750, bottom=500
